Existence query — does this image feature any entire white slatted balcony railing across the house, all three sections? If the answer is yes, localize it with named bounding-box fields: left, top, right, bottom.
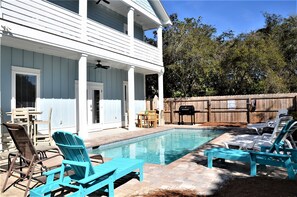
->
left=0, top=0, right=162, bottom=65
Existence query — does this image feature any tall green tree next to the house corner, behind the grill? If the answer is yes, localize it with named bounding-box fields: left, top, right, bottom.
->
left=163, top=14, right=218, bottom=97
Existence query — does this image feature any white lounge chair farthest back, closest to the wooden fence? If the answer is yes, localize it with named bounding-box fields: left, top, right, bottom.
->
left=247, top=109, right=288, bottom=135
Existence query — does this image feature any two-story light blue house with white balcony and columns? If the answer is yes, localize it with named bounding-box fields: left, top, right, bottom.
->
left=0, top=0, right=171, bottom=137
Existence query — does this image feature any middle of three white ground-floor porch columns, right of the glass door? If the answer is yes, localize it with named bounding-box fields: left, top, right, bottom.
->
left=128, top=66, right=136, bottom=131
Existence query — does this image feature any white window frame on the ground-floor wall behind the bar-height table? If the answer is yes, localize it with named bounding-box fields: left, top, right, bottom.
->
left=10, top=66, right=40, bottom=110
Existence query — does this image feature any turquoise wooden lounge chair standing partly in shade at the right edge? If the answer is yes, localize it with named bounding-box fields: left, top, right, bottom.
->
left=204, top=120, right=297, bottom=180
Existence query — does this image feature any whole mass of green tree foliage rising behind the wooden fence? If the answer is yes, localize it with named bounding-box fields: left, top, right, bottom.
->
left=148, top=13, right=297, bottom=97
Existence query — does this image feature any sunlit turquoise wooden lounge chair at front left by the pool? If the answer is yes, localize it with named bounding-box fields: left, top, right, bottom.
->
left=30, top=131, right=144, bottom=197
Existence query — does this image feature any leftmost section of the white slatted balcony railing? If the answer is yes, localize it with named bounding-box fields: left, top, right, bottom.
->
left=1, top=0, right=81, bottom=39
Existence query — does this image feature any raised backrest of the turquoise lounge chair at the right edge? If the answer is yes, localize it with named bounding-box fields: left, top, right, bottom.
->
left=269, top=117, right=297, bottom=153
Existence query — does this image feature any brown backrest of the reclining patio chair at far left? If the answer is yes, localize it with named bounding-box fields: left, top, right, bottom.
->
left=3, top=123, right=38, bottom=161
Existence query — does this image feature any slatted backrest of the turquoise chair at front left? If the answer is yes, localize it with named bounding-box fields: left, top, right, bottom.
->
left=53, top=131, right=95, bottom=178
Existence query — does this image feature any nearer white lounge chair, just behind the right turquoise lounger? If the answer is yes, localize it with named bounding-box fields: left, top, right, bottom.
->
left=224, top=116, right=296, bottom=150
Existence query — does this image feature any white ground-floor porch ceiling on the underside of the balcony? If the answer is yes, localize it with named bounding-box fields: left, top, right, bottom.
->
left=0, top=36, right=160, bottom=75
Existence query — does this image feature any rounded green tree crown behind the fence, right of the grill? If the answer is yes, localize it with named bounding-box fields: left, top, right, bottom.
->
left=216, top=32, right=286, bottom=95
